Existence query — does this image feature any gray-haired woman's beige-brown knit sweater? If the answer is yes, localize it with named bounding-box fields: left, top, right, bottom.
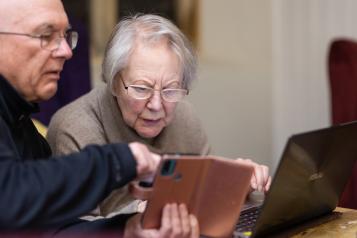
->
left=47, top=85, right=210, bottom=216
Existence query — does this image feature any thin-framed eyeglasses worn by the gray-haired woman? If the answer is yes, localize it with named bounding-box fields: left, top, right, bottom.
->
left=120, top=76, right=188, bottom=102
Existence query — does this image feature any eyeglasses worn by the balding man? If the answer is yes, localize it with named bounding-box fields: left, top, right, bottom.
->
left=0, top=30, right=78, bottom=51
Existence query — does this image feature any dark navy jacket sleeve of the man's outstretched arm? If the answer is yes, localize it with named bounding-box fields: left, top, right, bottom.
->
left=0, top=140, right=136, bottom=229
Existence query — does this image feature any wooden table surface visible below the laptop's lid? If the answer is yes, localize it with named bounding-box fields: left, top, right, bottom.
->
left=273, top=207, right=357, bottom=238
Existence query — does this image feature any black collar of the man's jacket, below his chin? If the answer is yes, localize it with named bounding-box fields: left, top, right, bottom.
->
left=0, top=75, right=39, bottom=125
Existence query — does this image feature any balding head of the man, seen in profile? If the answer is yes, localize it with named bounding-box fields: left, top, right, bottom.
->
left=0, top=0, right=72, bottom=101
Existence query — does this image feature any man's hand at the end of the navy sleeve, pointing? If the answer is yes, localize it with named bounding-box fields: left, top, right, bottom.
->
left=129, top=142, right=161, bottom=180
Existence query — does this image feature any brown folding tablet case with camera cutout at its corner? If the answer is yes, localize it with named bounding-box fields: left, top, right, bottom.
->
left=134, top=155, right=253, bottom=237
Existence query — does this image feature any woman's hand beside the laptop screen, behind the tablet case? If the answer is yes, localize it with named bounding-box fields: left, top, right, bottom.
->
left=236, top=158, right=271, bottom=192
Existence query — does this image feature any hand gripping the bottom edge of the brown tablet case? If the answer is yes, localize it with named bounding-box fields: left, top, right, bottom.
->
left=124, top=204, right=200, bottom=238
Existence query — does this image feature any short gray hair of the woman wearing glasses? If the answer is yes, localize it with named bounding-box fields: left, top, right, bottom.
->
left=102, top=14, right=197, bottom=92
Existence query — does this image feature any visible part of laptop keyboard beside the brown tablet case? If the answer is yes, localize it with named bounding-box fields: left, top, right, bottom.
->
left=236, top=206, right=261, bottom=232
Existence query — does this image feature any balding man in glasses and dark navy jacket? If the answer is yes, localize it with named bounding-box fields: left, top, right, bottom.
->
left=0, top=0, right=198, bottom=237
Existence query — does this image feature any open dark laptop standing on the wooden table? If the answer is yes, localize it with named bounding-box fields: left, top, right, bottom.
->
left=234, top=122, right=357, bottom=237
